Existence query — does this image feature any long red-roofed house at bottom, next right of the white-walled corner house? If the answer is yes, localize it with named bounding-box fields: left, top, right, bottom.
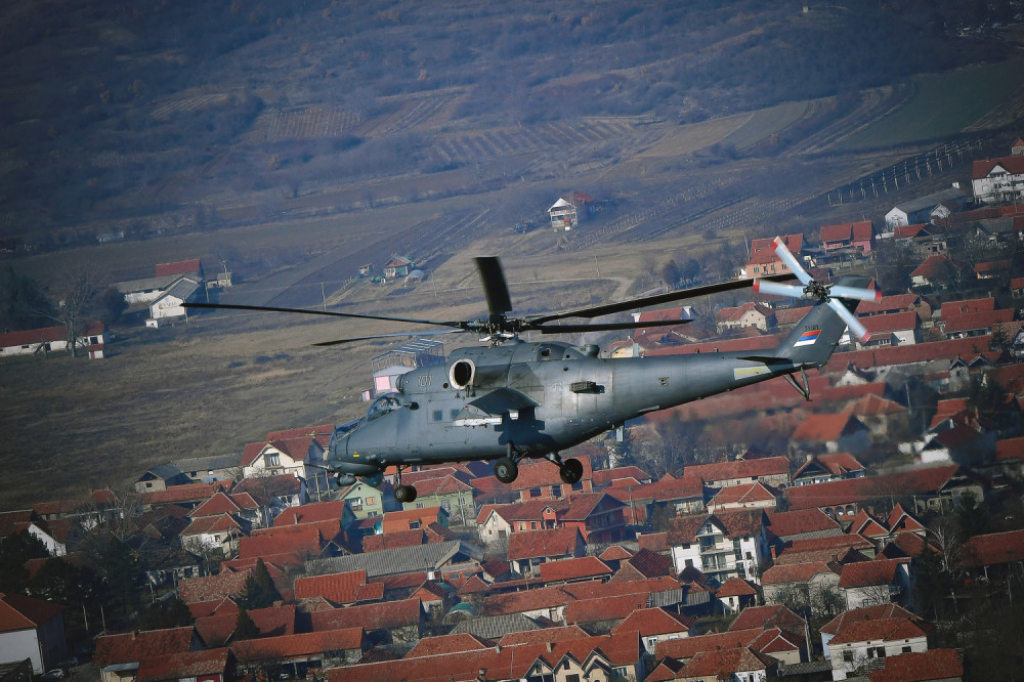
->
left=92, top=626, right=201, bottom=682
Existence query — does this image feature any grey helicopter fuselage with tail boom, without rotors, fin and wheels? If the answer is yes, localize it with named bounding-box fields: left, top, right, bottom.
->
left=329, top=340, right=800, bottom=475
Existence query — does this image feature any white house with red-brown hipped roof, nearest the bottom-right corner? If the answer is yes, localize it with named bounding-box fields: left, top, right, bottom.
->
left=827, top=617, right=928, bottom=680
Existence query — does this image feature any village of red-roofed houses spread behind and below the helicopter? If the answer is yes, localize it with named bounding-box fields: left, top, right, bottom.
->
left=0, top=140, right=1024, bottom=682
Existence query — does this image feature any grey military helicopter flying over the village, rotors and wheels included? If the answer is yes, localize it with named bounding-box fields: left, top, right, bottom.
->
left=187, top=238, right=881, bottom=503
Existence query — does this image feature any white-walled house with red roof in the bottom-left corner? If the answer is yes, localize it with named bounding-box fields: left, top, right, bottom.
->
left=0, top=592, right=68, bottom=675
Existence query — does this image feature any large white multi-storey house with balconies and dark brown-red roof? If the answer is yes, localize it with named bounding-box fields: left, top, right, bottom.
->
left=668, top=509, right=769, bottom=582
